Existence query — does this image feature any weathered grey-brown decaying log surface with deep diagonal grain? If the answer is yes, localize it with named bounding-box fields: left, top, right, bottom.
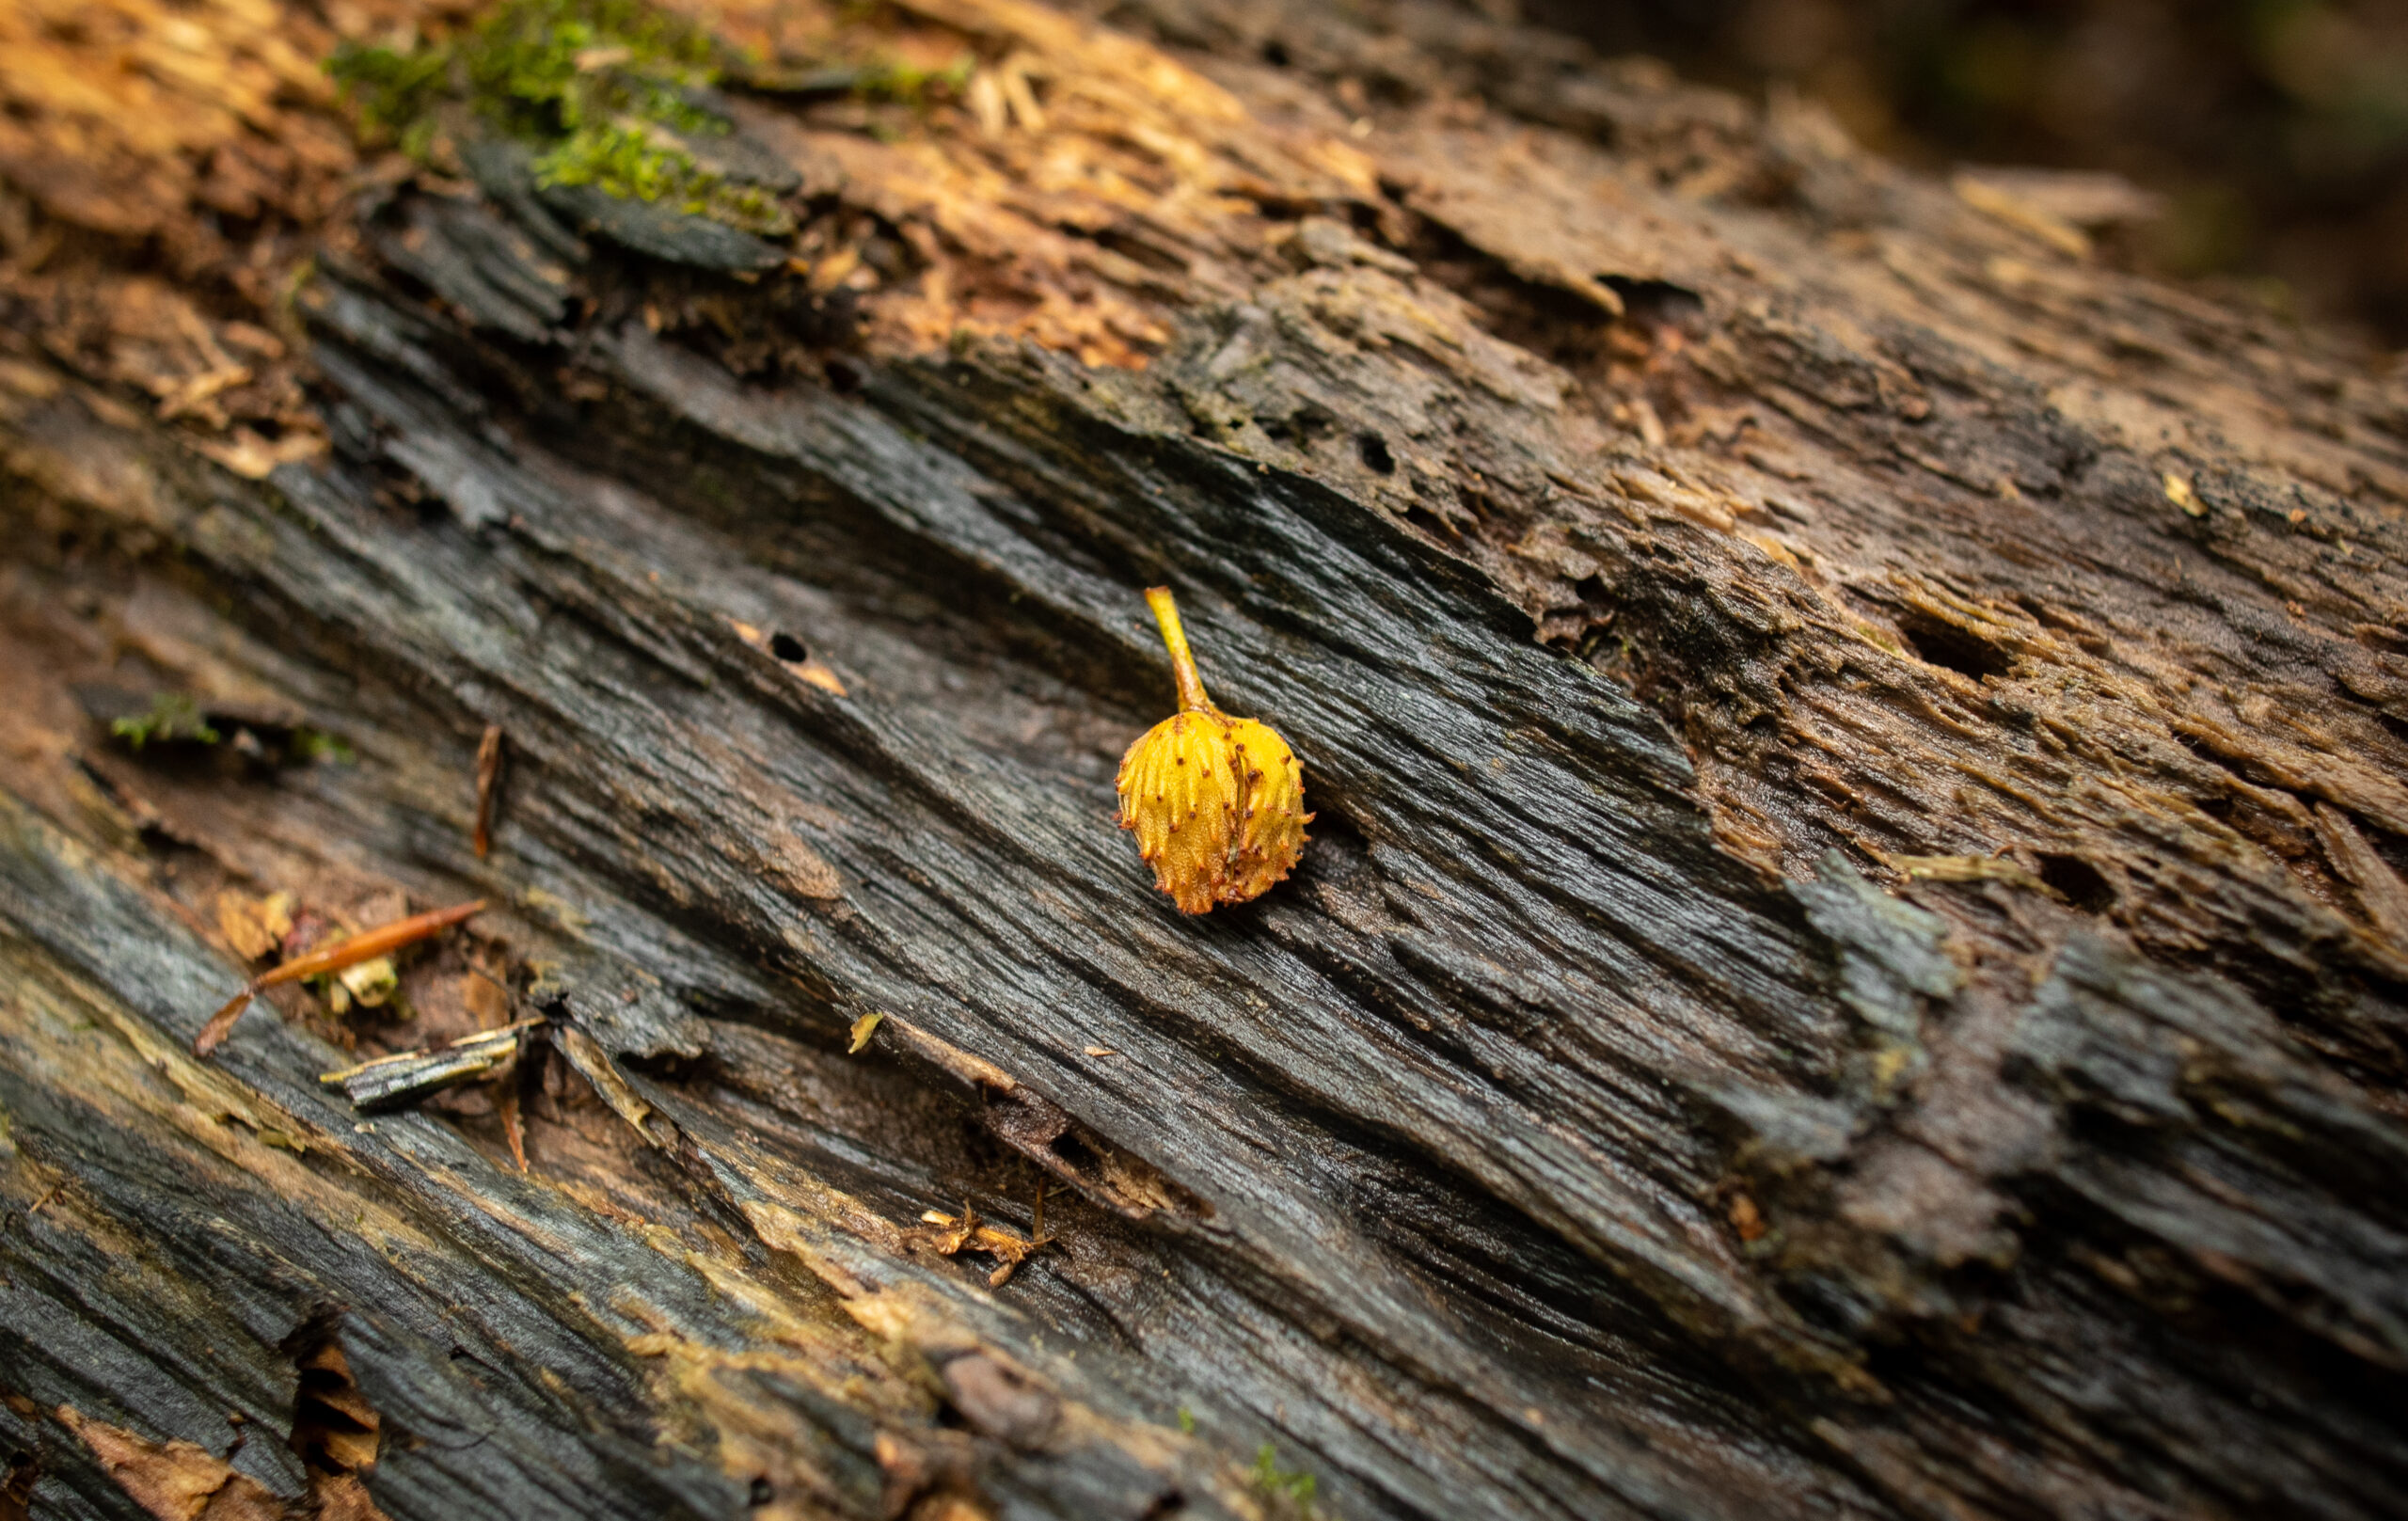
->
left=0, top=0, right=2408, bottom=1518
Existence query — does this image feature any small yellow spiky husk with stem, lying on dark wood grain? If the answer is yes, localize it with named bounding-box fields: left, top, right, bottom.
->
left=1119, top=587, right=1312, bottom=914
